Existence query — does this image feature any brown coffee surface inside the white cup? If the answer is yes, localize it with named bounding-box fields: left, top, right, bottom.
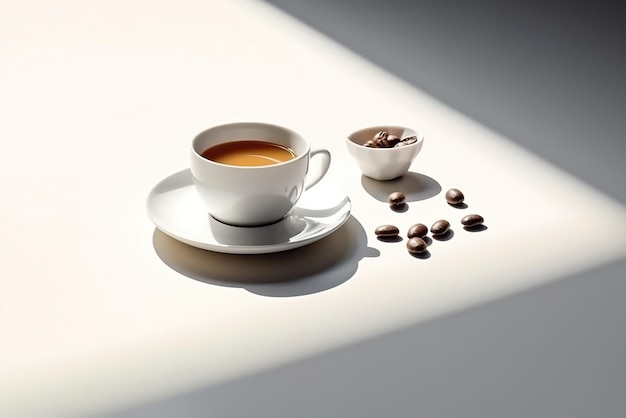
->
left=201, top=140, right=296, bottom=167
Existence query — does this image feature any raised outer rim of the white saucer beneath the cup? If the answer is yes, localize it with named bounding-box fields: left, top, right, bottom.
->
left=146, top=168, right=352, bottom=254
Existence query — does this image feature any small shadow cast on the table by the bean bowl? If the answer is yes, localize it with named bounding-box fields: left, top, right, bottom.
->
left=361, top=171, right=441, bottom=202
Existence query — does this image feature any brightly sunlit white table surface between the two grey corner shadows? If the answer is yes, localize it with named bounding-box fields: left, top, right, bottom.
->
left=0, top=0, right=626, bottom=416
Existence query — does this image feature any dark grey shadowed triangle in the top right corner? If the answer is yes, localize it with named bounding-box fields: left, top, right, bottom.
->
left=265, top=0, right=626, bottom=203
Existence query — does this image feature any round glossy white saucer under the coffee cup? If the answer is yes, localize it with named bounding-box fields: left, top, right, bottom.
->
left=147, top=169, right=351, bottom=254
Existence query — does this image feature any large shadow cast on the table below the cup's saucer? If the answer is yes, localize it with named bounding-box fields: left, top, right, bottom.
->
left=152, top=216, right=380, bottom=297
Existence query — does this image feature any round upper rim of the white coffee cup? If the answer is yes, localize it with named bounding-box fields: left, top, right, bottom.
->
left=191, top=122, right=311, bottom=170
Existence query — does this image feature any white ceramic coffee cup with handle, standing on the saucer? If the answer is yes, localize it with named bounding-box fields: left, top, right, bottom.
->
left=191, top=122, right=330, bottom=226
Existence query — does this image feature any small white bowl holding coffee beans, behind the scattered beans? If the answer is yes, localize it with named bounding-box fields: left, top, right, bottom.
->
left=346, top=125, right=424, bottom=180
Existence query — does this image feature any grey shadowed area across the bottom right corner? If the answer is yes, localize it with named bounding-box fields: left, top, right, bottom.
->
left=101, top=260, right=626, bottom=418
